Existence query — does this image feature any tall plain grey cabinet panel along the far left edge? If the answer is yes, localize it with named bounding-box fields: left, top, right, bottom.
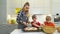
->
left=0, top=0, right=7, bottom=24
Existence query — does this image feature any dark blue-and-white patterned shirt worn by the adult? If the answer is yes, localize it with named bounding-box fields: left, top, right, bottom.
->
left=16, top=10, right=28, bottom=24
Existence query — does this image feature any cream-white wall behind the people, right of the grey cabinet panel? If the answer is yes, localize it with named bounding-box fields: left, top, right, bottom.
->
left=7, top=0, right=60, bottom=23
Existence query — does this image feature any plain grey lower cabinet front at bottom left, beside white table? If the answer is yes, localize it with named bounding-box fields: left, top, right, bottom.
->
left=0, top=24, right=17, bottom=34
